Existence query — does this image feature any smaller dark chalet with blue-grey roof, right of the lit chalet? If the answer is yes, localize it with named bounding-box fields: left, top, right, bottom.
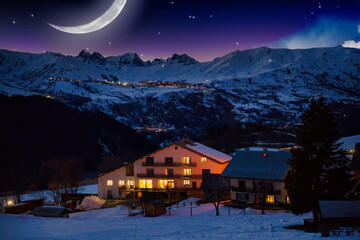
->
left=221, top=150, right=291, bottom=205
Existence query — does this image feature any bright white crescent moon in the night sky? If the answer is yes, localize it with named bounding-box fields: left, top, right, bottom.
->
left=48, top=0, right=127, bottom=34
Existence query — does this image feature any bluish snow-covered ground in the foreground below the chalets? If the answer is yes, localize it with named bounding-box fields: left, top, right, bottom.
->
left=0, top=199, right=360, bottom=240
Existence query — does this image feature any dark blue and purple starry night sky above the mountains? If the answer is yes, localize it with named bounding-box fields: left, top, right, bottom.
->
left=0, top=0, right=360, bottom=61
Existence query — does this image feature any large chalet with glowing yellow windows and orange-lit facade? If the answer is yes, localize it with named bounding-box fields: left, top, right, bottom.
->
left=98, top=139, right=232, bottom=199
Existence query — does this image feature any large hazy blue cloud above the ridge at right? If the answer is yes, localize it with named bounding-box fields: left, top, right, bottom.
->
left=278, top=16, right=360, bottom=49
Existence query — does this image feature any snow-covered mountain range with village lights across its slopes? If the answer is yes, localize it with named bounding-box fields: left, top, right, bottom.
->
left=0, top=46, right=360, bottom=141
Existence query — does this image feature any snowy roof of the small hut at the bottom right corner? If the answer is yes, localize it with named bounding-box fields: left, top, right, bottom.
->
left=319, top=201, right=360, bottom=218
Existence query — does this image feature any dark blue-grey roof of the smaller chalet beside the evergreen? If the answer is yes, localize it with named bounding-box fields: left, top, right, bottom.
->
left=221, top=151, right=291, bottom=180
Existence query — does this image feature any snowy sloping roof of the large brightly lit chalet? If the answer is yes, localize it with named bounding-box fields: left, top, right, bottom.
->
left=176, top=139, right=232, bottom=163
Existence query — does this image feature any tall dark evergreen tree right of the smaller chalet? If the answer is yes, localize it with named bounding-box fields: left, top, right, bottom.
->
left=285, top=97, right=354, bottom=221
